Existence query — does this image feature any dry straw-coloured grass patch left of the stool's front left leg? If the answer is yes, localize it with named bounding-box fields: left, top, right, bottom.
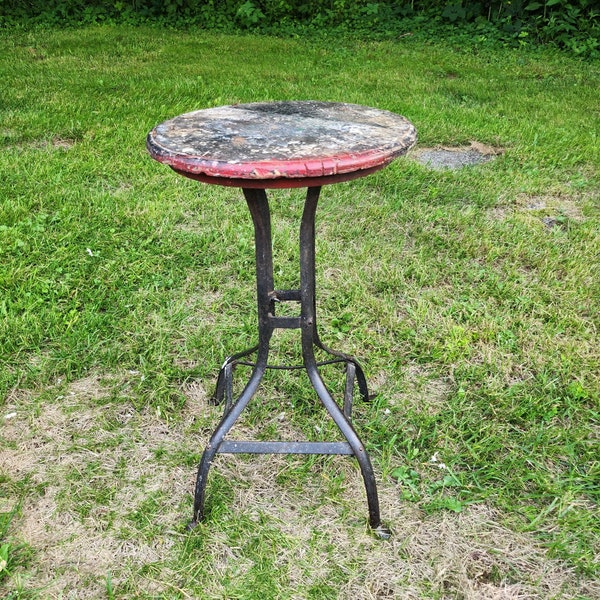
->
left=0, top=376, right=192, bottom=598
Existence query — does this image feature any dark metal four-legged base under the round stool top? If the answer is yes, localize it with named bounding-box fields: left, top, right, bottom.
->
left=191, top=187, right=390, bottom=538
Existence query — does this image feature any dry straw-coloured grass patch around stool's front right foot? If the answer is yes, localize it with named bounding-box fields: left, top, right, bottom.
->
left=216, top=457, right=600, bottom=600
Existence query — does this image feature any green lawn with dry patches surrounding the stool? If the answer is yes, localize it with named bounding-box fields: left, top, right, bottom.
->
left=0, top=27, right=600, bottom=599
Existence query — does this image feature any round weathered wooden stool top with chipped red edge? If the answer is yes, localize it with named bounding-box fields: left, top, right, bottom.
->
left=146, top=101, right=417, bottom=188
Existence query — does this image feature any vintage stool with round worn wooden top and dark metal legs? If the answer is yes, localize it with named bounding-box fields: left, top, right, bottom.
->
left=147, top=101, right=416, bottom=537
